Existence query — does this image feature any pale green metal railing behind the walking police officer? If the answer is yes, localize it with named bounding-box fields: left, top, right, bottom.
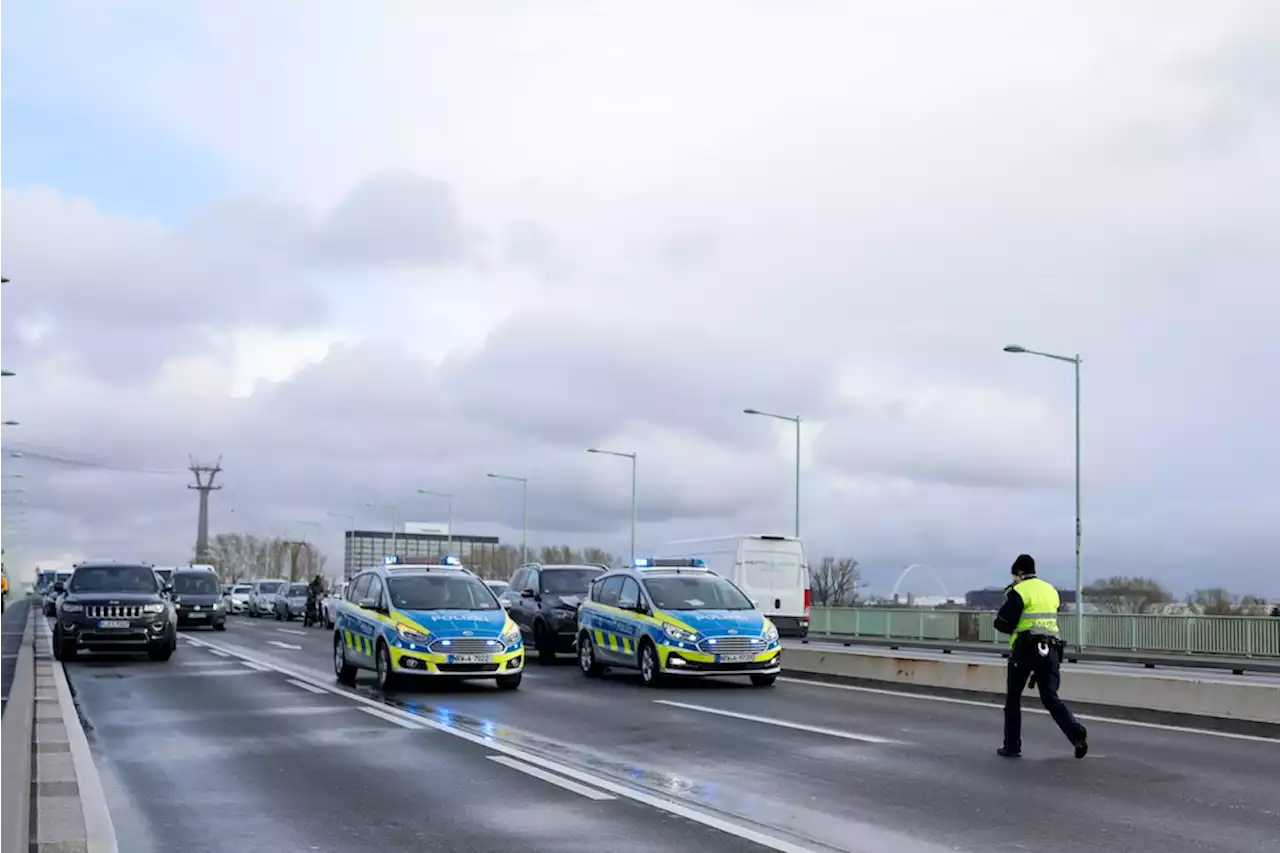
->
left=809, top=607, right=1280, bottom=658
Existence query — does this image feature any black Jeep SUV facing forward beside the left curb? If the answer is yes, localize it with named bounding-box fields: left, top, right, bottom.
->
left=54, top=562, right=178, bottom=661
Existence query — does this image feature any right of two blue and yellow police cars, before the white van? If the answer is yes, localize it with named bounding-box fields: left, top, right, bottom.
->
left=577, top=558, right=782, bottom=686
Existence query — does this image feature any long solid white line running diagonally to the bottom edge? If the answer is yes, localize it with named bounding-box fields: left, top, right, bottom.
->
left=190, top=637, right=818, bottom=853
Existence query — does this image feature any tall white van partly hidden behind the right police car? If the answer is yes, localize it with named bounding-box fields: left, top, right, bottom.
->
left=653, top=533, right=813, bottom=637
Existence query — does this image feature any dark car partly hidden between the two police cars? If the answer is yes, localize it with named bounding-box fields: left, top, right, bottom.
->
left=500, top=564, right=605, bottom=663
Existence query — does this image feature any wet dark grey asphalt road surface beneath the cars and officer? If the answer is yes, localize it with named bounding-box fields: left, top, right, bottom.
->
left=68, top=617, right=1280, bottom=853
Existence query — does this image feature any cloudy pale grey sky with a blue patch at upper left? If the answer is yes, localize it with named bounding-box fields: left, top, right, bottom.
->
left=0, top=0, right=1280, bottom=596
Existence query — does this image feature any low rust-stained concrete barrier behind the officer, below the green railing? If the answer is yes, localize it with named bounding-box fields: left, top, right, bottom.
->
left=783, top=647, right=1280, bottom=734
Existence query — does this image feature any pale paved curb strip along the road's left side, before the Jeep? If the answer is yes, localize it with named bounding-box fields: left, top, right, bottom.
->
left=29, top=613, right=116, bottom=853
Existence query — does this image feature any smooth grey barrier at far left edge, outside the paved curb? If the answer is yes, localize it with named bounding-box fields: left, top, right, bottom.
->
left=0, top=608, right=37, bottom=853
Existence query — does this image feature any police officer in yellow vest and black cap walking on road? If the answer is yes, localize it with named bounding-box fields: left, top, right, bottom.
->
left=996, top=553, right=1089, bottom=758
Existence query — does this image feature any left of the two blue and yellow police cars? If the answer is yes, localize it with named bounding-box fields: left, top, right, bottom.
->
left=333, top=557, right=525, bottom=690
